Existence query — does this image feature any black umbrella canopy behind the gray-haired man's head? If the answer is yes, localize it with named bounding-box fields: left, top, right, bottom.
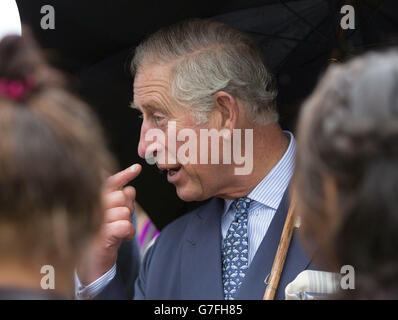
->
left=17, top=0, right=398, bottom=229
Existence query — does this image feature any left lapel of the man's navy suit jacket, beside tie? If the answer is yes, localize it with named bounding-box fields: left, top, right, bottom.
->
left=181, top=198, right=224, bottom=300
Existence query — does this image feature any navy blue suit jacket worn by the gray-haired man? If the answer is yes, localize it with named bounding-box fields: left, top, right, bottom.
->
left=102, top=192, right=317, bottom=300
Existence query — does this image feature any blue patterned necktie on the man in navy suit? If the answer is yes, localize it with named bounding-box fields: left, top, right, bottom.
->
left=222, top=197, right=252, bottom=300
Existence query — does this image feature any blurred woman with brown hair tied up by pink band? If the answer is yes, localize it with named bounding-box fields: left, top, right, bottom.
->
left=0, top=36, right=113, bottom=299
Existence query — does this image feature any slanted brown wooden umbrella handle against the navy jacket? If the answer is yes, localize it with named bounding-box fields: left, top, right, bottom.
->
left=263, top=199, right=295, bottom=300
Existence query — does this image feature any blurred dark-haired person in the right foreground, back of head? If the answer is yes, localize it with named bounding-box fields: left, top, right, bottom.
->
left=294, top=51, right=398, bottom=299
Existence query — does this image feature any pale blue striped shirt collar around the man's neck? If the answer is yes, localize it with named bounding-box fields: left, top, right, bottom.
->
left=224, top=131, right=296, bottom=214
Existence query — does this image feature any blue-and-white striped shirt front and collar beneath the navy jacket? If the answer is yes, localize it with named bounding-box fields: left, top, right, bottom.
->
left=221, top=131, right=296, bottom=265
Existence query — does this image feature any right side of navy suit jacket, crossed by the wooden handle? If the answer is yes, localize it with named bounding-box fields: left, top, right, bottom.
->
left=236, top=191, right=310, bottom=300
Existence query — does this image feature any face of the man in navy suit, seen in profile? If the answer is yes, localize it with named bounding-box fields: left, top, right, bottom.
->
left=134, top=64, right=230, bottom=201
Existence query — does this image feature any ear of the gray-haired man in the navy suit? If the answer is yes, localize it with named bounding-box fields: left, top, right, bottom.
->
left=214, top=91, right=239, bottom=131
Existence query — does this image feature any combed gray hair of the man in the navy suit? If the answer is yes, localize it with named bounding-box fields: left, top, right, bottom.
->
left=132, top=19, right=278, bottom=125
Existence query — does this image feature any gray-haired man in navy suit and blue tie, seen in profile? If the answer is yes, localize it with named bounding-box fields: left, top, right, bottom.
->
left=79, top=20, right=316, bottom=299
